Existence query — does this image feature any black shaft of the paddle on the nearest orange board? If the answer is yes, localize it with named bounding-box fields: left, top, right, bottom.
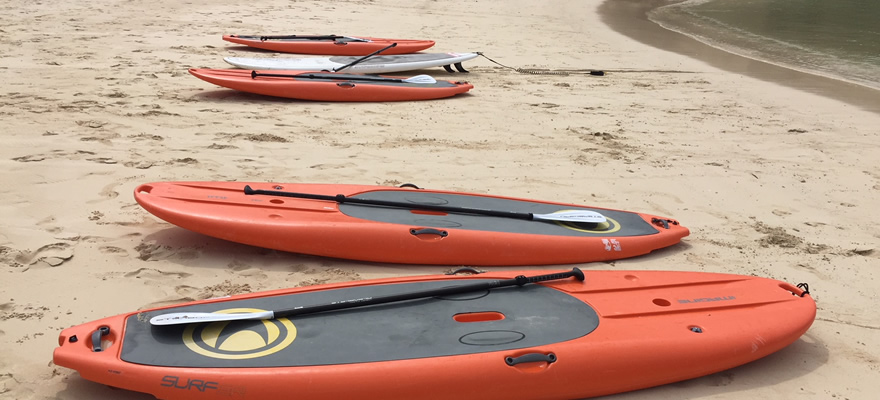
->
left=274, top=267, right=584, bottom=318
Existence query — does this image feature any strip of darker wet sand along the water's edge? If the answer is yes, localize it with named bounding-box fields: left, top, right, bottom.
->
left=597, top=0, right=880, bottom=114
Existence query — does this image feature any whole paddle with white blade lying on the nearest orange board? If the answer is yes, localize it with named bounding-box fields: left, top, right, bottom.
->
left=150, top=268, right=584, bottom=325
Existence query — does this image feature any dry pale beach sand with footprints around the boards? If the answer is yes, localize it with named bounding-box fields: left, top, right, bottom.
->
left=0, top=0, right=880, bottom=399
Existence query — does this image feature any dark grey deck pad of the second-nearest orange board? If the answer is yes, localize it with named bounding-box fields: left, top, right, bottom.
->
left=339, top=190, right=658, bottom=237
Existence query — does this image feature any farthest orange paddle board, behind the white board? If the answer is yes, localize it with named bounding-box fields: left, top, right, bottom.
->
left=223, top=35, right=434, bottom=56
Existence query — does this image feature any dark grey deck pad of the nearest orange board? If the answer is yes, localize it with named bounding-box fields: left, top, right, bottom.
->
left=121, top=280, right=599, bottom=368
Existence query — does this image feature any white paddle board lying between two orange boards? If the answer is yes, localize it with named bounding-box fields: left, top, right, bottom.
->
left=223, top=53, right=479, bottom=74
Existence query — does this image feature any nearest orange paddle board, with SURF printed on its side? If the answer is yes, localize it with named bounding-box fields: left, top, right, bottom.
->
left=54, top=271, right=816, bottom=400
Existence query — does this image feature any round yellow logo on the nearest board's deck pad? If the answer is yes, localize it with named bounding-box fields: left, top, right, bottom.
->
left=183, top=308, right=296, bottom=360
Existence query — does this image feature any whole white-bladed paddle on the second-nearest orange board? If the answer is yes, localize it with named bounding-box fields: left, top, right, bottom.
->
left=244, top=185, right=606, bottom=224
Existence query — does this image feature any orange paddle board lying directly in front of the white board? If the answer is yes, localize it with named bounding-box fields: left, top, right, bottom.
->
left=189, top=68, right=474, bottom=101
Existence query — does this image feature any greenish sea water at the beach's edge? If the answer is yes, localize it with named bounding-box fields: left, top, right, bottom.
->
left=649, top=0, right=880, bottom=89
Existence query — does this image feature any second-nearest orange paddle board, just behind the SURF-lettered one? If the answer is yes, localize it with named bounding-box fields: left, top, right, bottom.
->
left=134, top=182, right=689, bottom=265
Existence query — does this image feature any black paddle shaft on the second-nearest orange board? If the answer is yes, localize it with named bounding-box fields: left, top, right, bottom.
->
left=244, top=185, right=535, bottom=221
